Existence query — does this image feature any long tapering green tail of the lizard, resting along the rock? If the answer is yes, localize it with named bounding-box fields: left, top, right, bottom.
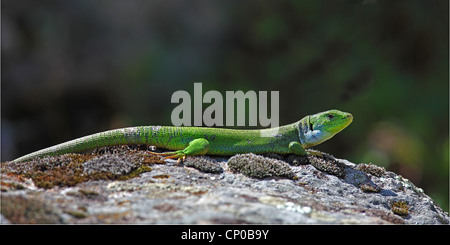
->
left=13, top=126, right=172, bottom=162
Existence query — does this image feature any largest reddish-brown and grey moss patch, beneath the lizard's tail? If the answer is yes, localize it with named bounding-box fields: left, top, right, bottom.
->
left=1, top=146, right=164, bottom=189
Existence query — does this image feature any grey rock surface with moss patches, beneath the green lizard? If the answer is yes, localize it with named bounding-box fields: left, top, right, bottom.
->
left=1, top=147, right=449, bottom=224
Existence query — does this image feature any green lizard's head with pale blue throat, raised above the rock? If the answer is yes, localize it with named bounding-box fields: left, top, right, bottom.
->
left=299, top=110, right=353, bottom=148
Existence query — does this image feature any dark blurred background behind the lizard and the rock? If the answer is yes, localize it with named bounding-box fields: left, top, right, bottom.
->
left=1, top=0, right=449, bottom=211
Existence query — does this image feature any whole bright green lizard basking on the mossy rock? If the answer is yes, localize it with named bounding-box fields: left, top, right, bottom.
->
left=14, top=110, right=353, bottom=162
